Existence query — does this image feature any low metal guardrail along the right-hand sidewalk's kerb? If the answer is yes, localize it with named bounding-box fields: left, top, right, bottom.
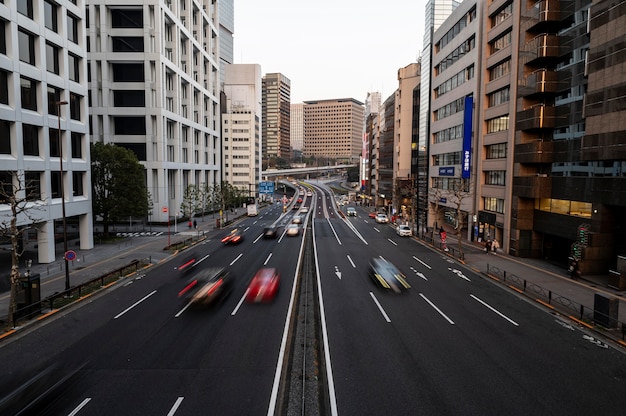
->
left=487, top=264, right=626, bottom=341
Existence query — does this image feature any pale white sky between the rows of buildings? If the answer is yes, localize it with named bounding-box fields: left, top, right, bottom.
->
left=233, top=0, right=426, bottom=103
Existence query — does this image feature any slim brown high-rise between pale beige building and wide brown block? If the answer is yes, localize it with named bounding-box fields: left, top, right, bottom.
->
left=262, top=73, right=291, bottom=166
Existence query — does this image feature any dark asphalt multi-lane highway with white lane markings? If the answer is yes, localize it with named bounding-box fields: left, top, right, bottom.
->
left=0, top=183, right=626, bottom=415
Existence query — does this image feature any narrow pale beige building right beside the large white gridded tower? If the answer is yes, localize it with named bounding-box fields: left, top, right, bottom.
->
left=222, top=64, right=262, bottom=196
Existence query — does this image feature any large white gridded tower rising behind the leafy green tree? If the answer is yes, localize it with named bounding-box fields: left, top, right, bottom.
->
left=87, top=0, right=221, bottom=221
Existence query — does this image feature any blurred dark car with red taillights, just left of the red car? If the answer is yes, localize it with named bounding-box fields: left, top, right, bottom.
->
left=178, top=267, right=233, bottom=306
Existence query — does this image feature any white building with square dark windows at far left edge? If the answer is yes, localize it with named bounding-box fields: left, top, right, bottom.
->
left=0, top=1, right=93, bottom=263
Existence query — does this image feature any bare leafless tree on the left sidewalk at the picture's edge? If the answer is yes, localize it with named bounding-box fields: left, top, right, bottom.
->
left=0, top=172, right=41, bottom=327
